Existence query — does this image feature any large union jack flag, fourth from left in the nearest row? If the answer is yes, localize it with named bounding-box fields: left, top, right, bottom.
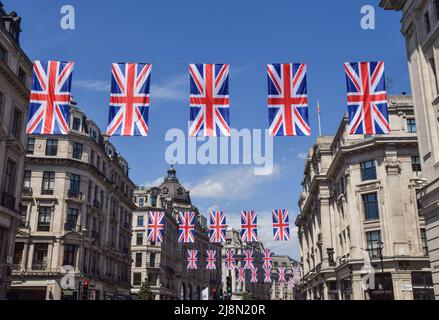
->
left=267, top=63, right=311, bottom=136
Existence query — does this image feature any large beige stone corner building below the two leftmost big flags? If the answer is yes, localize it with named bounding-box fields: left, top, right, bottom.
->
left=9, top=103, right=135, bottom=300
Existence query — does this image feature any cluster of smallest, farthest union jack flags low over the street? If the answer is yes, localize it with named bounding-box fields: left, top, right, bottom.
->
left=187, top=249, right=299, bottom=287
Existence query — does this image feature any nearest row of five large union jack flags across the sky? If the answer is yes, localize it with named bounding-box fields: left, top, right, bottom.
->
left=27, top=61, right=390, bottom=136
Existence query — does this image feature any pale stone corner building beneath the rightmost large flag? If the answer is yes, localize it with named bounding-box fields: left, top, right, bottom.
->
left=296, top=96, right=434, bottom=300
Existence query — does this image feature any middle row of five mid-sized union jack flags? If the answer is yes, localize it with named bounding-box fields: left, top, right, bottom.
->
left=146, top=209, right=291, bottom=243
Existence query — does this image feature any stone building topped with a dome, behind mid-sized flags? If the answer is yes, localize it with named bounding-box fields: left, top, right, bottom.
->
left=131, top=167, right=222, bottom=300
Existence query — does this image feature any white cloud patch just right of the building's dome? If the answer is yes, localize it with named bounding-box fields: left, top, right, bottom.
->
left=190, top=166, right=279, bottom=200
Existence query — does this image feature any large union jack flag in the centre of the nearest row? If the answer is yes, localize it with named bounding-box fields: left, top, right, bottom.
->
left=189, top=64, right=230, bottom=137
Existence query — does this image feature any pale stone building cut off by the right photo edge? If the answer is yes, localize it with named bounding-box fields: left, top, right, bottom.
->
left=380, top=0, right=439, bottom=299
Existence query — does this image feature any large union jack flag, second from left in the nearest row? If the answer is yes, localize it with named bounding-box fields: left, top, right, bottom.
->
left=107, top=63, right=151, bottom=136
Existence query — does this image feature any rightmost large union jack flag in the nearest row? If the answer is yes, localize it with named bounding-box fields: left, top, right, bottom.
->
left=345, top=61, right=390, bottom=134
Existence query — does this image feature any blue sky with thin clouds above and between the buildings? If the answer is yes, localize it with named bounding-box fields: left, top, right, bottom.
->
left=7, top=0, right=410, bottom=258
